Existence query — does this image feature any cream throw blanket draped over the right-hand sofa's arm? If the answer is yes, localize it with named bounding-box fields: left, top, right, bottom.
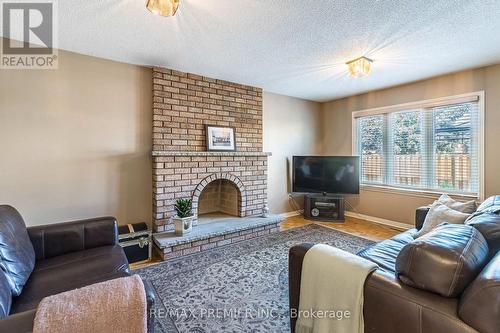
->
left=292, top=244, right=377, bottom=333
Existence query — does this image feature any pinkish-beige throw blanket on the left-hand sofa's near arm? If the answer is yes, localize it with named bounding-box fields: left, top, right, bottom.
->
left=33, top=275, right=147, bottom=333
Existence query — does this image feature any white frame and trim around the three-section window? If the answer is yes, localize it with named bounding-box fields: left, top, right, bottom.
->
left=352, top=91, right=485, bottom=201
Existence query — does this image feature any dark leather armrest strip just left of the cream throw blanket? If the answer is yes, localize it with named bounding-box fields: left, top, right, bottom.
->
left=288, top=243, right=314, bottom=333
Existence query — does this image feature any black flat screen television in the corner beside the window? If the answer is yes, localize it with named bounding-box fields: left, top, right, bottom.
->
left=292, top=156, right=360, bottom=194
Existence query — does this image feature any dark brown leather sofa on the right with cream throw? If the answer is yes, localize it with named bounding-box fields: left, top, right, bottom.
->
left=289, top=196, right=500, bottom=333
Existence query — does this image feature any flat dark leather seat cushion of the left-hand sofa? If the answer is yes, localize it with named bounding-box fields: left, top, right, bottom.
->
left=11, top=245, right=129, bottom=313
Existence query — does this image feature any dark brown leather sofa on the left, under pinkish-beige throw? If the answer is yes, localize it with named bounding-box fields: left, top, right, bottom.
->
left=0, top=205, right=155, bottom=333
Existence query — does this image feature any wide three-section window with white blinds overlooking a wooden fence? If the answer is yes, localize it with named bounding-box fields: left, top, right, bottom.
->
left=353, top=93, right=483, bottom=198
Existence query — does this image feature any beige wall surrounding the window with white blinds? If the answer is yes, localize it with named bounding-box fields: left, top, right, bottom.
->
left=323, top=65, right=500, bottom=223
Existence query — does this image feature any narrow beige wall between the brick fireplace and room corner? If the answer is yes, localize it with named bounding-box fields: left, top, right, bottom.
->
left=263, top=92, right=322, bottom=214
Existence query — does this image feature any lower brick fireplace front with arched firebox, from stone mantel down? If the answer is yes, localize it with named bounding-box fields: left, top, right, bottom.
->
left=153, top=152, right=268, bottom=232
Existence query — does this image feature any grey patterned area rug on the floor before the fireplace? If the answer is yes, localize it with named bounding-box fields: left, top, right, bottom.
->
left=135, top=225, right=373, bottom=333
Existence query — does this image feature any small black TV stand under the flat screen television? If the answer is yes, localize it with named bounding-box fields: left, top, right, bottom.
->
left=304, top=192, right=345, bottom=222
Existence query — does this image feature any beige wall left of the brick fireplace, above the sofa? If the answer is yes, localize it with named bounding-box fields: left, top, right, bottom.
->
left=0, top=44, right=152, bottom=225
